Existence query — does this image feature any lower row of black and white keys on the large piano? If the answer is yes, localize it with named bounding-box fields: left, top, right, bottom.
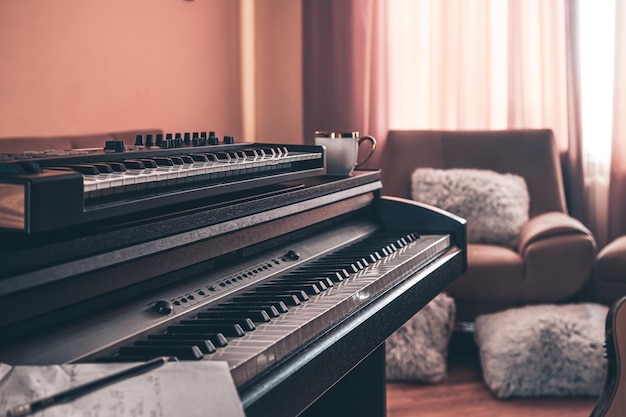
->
left=98, top=232, right=450, bottom=385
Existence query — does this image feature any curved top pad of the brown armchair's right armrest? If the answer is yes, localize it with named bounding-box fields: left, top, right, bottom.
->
left=518, top=211, right=593, bottom=257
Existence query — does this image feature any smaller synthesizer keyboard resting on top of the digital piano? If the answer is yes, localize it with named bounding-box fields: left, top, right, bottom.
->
left=0, top=143, right=325, bottom=233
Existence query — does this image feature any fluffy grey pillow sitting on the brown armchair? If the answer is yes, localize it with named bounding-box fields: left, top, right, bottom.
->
left=411, top=168, right=530, bottom=249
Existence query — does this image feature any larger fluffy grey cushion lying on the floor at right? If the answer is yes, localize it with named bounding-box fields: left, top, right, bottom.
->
left=475, top=303, right=608, bottom=398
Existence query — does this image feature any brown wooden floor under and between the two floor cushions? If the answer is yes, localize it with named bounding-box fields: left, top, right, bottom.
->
left=387, top=334, right=597, bottom=417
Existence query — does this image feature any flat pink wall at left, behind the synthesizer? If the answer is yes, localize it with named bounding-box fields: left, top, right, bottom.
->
left=0, top=0, right=242, bottom=138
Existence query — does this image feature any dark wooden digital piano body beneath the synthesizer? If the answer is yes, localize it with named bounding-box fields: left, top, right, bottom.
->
left=0, top=141, right=467, bottom=416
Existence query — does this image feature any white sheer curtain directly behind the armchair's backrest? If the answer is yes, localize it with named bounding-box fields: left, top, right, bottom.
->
left=388, top=0, right=567, bottom=148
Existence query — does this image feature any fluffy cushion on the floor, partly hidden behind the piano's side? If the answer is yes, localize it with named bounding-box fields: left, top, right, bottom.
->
left=386, top=294, right=456, bottom=383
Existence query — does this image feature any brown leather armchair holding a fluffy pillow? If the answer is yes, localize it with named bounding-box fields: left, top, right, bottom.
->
left=381, top=130, right=596, bottom=322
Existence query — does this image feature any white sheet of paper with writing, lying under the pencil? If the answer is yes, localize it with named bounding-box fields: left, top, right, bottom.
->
left=0, top=361, right=244, bottom=417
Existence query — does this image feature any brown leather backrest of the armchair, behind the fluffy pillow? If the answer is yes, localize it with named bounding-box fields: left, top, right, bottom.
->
left=381, top=129, right=567, bottom=217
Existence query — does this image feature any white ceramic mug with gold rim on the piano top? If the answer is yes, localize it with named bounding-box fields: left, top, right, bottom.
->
left=315, top=131, right=376, bottom=175
